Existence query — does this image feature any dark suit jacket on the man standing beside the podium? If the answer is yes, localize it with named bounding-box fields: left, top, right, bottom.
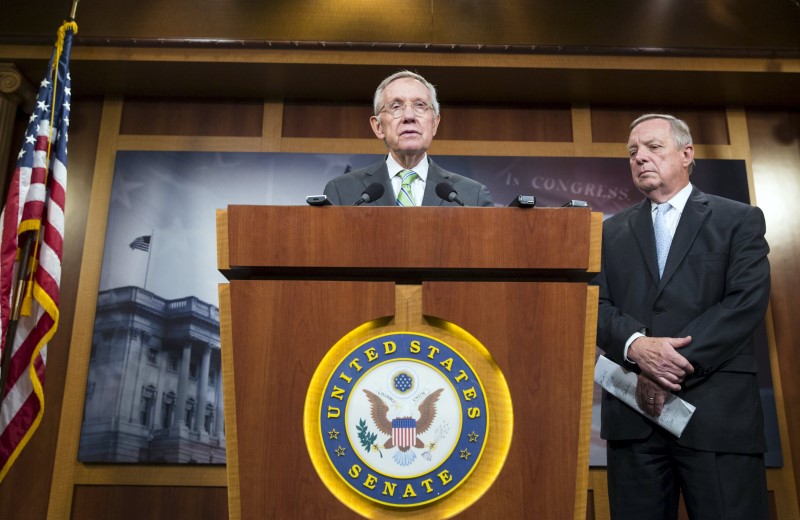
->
left=595, top=188, right=770, bottom=453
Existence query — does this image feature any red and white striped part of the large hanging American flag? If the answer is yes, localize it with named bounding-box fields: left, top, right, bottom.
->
left=0, top=120, right=67, bottom=480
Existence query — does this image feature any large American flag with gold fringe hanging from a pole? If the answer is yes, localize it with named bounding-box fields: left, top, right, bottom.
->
left=0, top=22, right=78, bottom=481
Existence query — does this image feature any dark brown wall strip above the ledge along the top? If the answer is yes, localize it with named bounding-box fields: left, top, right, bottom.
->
left=0, top=0, right=800, bottom=53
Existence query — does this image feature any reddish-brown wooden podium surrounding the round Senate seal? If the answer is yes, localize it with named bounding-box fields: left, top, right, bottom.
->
left=217, top=206, right=602, bottom=520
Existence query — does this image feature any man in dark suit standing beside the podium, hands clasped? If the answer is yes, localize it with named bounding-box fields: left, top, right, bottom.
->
left=595, top=114, right=770, bottom=520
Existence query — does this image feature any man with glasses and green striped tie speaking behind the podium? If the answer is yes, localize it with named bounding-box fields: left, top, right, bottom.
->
left=324, top=71, right=492, bottom=206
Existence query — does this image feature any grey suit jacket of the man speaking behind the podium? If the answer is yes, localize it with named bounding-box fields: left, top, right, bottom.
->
left=324, top=157, right=492, bottom=206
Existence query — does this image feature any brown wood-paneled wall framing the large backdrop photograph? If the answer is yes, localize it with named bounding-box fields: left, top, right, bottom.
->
left=0, top=87, right=800, bottom=519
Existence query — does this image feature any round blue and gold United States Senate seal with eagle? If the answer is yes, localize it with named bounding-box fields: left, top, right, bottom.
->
left=307, top=332, right=491, bottom=508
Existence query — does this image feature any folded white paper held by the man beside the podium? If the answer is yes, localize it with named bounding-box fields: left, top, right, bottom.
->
left=594, top=356, right=695, bottom=437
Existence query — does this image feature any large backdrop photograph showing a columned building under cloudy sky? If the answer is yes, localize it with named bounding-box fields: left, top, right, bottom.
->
left=79, top=151, right=781, bottom=466
